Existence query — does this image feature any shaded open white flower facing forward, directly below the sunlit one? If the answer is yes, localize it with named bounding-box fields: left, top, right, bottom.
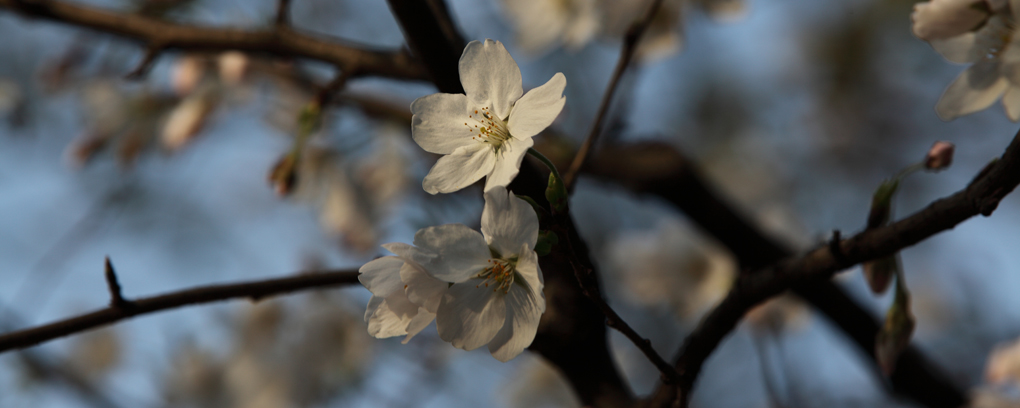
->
left=414, top=188, right=546, bottom=362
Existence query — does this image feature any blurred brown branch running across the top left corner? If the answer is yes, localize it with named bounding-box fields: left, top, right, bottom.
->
left=0, top=0, right=427, bottom=80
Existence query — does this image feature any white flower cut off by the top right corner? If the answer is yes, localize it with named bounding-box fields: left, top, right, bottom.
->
left=929, top=0, right=1020, bottom=121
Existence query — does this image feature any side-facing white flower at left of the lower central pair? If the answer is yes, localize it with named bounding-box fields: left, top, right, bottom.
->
left=358, top=243, right=448, bottom=343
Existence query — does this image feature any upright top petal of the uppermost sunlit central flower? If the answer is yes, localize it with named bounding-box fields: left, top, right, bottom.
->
left=459, top=40, right=524, bottom=119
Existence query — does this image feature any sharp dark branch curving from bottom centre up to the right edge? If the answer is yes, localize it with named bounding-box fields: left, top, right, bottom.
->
left=676, top=128, right=1020, bottom=398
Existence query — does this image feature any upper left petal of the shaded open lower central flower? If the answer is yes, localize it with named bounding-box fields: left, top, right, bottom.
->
left=414, top=223, right=490, bottom=283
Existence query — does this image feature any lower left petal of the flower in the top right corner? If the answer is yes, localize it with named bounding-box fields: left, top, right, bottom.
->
left=935, top=61, right=1009, bottom=120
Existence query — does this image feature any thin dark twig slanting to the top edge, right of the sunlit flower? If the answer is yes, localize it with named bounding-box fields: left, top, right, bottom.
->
left=563, top=0, right=662, bottom=192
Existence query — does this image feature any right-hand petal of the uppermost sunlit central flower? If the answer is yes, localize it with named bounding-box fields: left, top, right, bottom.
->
left=507, top=72, right=567, bottom=139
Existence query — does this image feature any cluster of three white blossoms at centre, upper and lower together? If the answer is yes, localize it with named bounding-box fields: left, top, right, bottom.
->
left=359, top=40, right=566, bottom=361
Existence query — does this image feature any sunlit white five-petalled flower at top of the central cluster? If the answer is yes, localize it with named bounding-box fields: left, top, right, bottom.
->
left=411, top=40, right=566, bottom=194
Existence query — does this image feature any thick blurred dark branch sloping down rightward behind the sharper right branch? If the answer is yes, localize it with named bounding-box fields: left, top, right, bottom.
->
left=584, top=142, right=967, bottom=408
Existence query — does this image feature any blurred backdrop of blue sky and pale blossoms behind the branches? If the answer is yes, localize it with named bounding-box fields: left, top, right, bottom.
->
left=0, top=0, right=1020, bottom=407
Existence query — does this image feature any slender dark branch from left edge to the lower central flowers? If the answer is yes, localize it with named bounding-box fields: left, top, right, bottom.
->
left=0, top=270, right=358, bottom=353
